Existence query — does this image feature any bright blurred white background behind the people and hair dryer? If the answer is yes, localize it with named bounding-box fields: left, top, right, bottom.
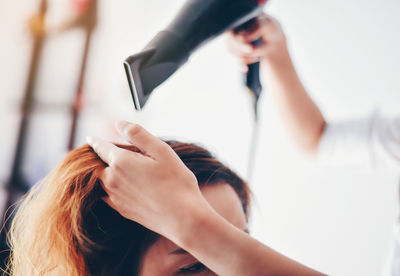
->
left=0, top=0, right=400, bottom=276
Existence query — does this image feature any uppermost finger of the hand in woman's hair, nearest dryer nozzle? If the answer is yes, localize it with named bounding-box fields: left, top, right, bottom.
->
left=116, top=121, right=174, bottom=159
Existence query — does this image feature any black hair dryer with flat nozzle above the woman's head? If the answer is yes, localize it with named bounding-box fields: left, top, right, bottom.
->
left=124, top=0, right=267, bottom=110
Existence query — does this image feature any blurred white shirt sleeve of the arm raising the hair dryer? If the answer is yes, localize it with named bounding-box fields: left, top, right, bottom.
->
left=318, top=112, right=400, bottom=169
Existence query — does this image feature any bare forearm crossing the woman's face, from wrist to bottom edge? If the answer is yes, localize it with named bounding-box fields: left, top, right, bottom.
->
left=176, top=203, right=323, bottom=276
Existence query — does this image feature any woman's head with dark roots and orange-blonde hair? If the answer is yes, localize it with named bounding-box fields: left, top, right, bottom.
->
left=10, top=141, right=249, bottom=276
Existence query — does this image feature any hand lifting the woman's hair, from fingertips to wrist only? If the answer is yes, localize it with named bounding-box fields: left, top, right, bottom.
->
left=88, top=121, right=208, bottom=243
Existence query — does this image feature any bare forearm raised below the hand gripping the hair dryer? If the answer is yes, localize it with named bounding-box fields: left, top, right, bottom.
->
left=262, top=47, right=326, bottom=154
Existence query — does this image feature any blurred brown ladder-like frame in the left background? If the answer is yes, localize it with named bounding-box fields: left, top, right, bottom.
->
left=0, top=0, right=97, bottom=269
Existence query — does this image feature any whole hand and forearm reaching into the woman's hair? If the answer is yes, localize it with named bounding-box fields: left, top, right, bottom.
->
left=88, top=122, right=322, bottom=276
